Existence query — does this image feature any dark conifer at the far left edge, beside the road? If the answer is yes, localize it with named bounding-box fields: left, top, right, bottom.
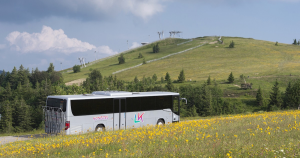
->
left=0, top=100, right=13, bottom=133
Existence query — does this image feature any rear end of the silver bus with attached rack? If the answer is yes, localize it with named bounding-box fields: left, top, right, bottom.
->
left=43, top=97, right=70, bottom=134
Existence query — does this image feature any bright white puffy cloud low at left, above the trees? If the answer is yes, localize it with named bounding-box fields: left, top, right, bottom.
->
left=6, top=26, right=96, bottom=54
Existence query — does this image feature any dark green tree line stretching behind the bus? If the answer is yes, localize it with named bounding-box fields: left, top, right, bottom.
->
left=0, top=63, right=300, bottom=133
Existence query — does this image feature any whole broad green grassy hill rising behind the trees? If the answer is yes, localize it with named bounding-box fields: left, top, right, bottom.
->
left=64, top=37, right=300, bottom=86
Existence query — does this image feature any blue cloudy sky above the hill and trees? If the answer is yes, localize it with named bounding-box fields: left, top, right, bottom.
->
left=0, top=0, right=300, bottom=71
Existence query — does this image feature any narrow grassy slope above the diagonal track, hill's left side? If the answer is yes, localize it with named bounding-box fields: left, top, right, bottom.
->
left=63, top=38, right=212, bottom=82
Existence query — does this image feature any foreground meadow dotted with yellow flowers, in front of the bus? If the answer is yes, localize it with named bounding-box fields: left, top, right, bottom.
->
left=0, top=111, right=300, bottom=157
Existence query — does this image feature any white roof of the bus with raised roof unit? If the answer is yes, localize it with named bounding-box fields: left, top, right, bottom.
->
left=48, top=91, right=179, bottom=100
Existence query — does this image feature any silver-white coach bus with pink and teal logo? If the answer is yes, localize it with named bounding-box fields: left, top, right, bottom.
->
left=43, top=91, right=186, bottom=135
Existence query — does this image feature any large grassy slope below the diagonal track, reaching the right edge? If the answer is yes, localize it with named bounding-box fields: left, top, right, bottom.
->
left=117, top=37, right=300, bottom=81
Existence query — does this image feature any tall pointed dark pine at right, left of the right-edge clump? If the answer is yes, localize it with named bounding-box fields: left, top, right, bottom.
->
left=268, top=80, right=282, bottom=111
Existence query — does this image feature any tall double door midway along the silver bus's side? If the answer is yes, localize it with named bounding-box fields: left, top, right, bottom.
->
left=114, top=98, right=126, bottom=130
